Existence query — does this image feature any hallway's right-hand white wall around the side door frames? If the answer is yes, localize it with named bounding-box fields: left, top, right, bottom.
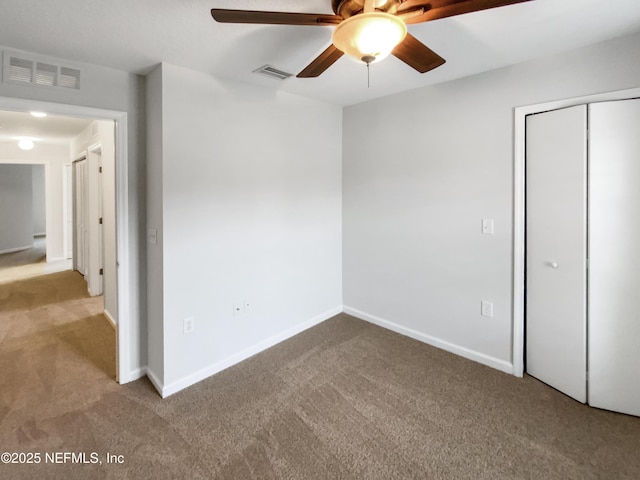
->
left=69, top=120, right=118, bottom=323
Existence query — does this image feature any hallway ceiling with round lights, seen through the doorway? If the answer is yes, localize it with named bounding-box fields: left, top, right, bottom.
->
left=0, top=111, right=91, bottom=144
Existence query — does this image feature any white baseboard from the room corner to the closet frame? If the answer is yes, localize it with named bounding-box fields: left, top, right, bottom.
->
left=343, top=306, right=513, bottom=374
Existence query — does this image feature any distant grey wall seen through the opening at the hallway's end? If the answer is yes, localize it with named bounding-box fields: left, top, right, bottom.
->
left=0, top=164, right=33, bottom=253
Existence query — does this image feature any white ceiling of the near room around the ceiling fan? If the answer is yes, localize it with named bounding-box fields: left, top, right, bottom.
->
left=0, top=0, right=640, bottom=105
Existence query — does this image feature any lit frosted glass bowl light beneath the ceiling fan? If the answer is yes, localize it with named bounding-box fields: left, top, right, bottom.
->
left=331, top=12, right=407, bottom=64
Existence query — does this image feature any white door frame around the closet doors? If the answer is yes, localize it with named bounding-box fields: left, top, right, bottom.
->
left=511, top=88, right=640, bottom=377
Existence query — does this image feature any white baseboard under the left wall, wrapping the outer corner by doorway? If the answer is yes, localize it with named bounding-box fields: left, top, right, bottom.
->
left=160, top=306, right=342, bottom=398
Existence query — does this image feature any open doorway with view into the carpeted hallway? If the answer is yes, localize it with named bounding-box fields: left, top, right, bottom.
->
left=0, top=108, right=118, bottom=377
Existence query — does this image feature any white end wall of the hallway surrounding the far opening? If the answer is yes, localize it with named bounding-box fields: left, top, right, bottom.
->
left=0, top=142, right=69, bottom=262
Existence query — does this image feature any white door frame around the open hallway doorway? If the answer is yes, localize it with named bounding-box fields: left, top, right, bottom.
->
left=0, top=97, right=132, bottom=383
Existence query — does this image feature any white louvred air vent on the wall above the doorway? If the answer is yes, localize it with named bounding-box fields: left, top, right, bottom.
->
left=2, top=50, right=81, bottom=90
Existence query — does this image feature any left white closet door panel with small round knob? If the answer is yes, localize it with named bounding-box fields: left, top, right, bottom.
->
left=526, top=105, right=587, bottom=403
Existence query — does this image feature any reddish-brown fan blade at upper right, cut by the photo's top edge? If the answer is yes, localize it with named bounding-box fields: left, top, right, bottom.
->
left=398, top=0, right=532, bottom=24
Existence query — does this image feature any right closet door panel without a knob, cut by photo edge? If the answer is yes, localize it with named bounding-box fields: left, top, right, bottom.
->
left=589, top=99, right=640, bottom=416
